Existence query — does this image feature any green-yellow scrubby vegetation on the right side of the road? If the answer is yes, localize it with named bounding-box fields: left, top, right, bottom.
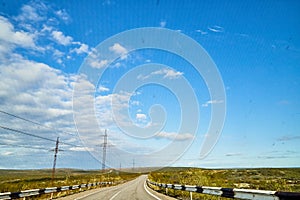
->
left=148, top=168, right=300, bottom=200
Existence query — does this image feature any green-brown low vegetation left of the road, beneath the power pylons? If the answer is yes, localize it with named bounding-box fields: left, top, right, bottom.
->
left=0, top=169, right=140, bottom=199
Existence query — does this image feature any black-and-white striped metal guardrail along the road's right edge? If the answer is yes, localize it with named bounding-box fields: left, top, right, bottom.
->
left=147, top=179, right=300, bottom=200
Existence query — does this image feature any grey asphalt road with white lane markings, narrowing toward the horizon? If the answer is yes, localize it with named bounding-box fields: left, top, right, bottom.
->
left=60, top=175, right=174, bottom=200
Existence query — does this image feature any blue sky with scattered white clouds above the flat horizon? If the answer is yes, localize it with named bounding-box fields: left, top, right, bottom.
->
left=0, top=0, right=300, bottom=169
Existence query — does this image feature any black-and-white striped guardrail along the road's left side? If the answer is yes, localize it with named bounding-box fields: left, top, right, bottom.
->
left=0, top=182, right=113, bottom=199
